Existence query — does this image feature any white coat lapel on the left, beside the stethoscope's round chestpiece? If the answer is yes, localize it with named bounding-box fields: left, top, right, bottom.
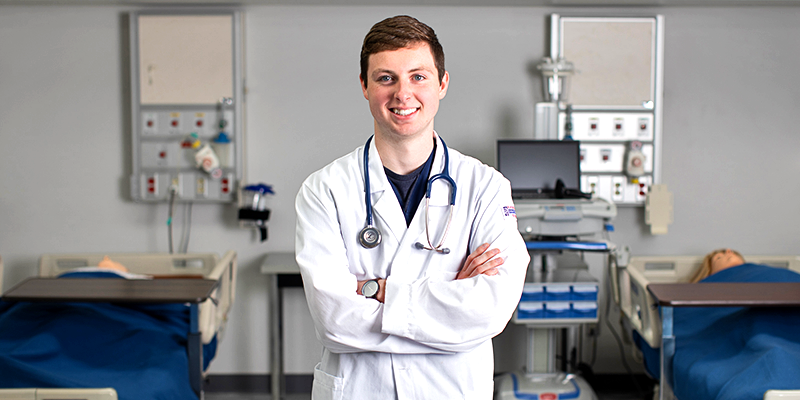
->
left=369, top=141, right=406, bottom=247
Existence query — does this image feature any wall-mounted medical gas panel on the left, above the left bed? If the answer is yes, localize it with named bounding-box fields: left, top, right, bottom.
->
left=129, top=11, right=244, bottom=202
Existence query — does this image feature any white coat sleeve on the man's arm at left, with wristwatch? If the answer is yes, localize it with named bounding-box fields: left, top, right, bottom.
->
left=295, top=180, right=450, bottom=354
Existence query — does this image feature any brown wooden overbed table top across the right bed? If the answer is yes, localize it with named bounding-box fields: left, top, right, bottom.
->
left=647, top=282, right=800, bottom=307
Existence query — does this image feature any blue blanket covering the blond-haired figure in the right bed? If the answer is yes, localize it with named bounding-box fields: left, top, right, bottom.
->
left=640, top=264, right=800, bottom=400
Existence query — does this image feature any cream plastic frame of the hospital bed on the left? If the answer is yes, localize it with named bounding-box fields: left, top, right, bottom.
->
left=0, top=251, right=238, bottom=400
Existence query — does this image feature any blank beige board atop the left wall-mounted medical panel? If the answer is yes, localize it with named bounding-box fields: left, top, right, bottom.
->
left=138, top=15, right=234, bottom=104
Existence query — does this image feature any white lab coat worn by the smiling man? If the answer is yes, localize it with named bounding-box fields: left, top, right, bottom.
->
left=296, top=137, right=530, bottom=400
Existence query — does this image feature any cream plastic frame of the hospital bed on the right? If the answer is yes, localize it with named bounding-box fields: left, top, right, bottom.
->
left=610, top=255, right=800, bottom=400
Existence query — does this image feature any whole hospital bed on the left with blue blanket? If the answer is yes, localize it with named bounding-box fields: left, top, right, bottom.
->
left=0, top=251, right=237, bottom=400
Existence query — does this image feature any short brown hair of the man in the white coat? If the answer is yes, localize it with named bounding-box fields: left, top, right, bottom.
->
left=361, top=15, right=445, bottom=87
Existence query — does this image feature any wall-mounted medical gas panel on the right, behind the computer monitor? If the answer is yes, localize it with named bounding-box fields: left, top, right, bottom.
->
left=551, top=15, right=664, bottom=206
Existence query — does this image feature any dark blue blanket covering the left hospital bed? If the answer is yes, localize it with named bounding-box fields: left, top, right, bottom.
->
left=0, top=276, right=216, bottom=400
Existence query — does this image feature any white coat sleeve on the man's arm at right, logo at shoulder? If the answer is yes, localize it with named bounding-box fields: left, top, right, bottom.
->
left=382, top=170, right=530, bottom=352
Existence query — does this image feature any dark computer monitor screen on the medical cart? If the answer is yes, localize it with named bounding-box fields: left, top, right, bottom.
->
left=497, top=140, right=581, bottom=198
